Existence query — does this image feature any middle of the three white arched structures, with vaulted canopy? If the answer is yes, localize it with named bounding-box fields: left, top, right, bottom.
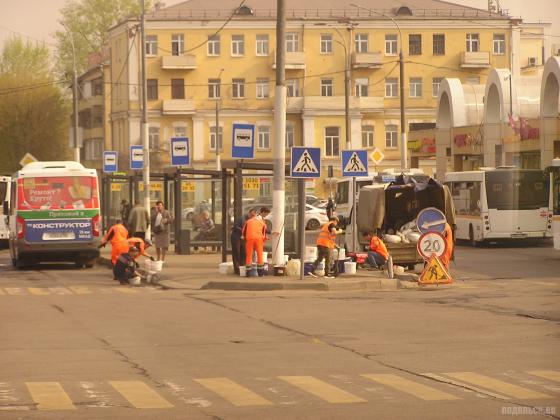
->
left=483, top=69, right=541, bottom=166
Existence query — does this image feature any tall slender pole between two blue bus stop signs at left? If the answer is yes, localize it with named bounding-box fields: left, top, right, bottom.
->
left=140, top=0, right=151, bottom=239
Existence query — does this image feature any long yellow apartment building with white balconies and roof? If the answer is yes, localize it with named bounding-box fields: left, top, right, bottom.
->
left=105, top=0, right=551, bottom=186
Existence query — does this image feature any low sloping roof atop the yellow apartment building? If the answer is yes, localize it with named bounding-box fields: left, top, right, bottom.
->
left=146, top=0, right=510, bottom=20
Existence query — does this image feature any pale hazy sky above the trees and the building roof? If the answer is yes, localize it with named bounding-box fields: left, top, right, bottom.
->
left=0, top=0, right=560, bottom=50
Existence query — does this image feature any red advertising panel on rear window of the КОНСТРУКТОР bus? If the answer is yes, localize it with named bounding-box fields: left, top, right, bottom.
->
left=18, top=176, right=99, bottom=210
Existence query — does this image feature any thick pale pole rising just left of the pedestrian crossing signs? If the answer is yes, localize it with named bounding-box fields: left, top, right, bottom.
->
left=272, top=0, right=286, bottom=267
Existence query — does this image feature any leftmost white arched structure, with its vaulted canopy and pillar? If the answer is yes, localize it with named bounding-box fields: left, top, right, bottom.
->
left=436, top=78, right=484, bottom=180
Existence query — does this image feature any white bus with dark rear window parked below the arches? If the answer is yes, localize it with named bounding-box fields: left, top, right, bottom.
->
left=445, top=167, right=552, bottom=246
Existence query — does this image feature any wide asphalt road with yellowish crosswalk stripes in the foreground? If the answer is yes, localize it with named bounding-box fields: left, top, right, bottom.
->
left=0, top=247, right=560, bottom=419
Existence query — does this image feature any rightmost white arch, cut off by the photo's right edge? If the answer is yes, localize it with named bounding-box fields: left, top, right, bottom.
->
left=540, top=57, right=560, bottom=168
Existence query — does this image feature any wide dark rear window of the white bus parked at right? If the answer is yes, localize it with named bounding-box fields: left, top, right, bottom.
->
left=486, top=171, right=548, bottom=210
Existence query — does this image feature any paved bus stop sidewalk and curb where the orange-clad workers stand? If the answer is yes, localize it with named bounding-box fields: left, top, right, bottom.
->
left=99, top=245, right=401, bottom=291
